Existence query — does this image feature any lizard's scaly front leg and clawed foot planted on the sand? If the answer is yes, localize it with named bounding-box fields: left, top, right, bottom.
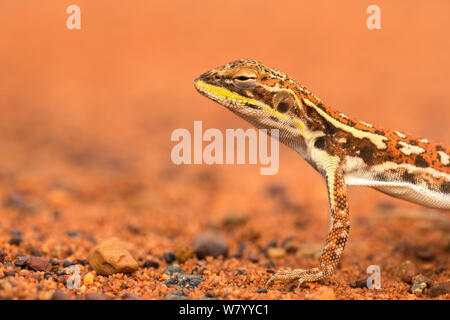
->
left=266, top=165, right=350, bottom=286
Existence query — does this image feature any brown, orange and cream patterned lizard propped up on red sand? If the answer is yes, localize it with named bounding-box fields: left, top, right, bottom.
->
left=194, top=59, right=450, bottom=286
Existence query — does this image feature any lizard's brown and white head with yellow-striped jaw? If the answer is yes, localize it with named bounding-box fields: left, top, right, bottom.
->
left=194, top=60, right=305, bottom=137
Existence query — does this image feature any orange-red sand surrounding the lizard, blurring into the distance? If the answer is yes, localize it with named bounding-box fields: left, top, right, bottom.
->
left=0, top=0, right=450, bottom=299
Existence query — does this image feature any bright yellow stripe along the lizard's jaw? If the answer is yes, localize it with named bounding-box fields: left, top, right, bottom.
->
left=194, top=80, right=305, bottom=130
